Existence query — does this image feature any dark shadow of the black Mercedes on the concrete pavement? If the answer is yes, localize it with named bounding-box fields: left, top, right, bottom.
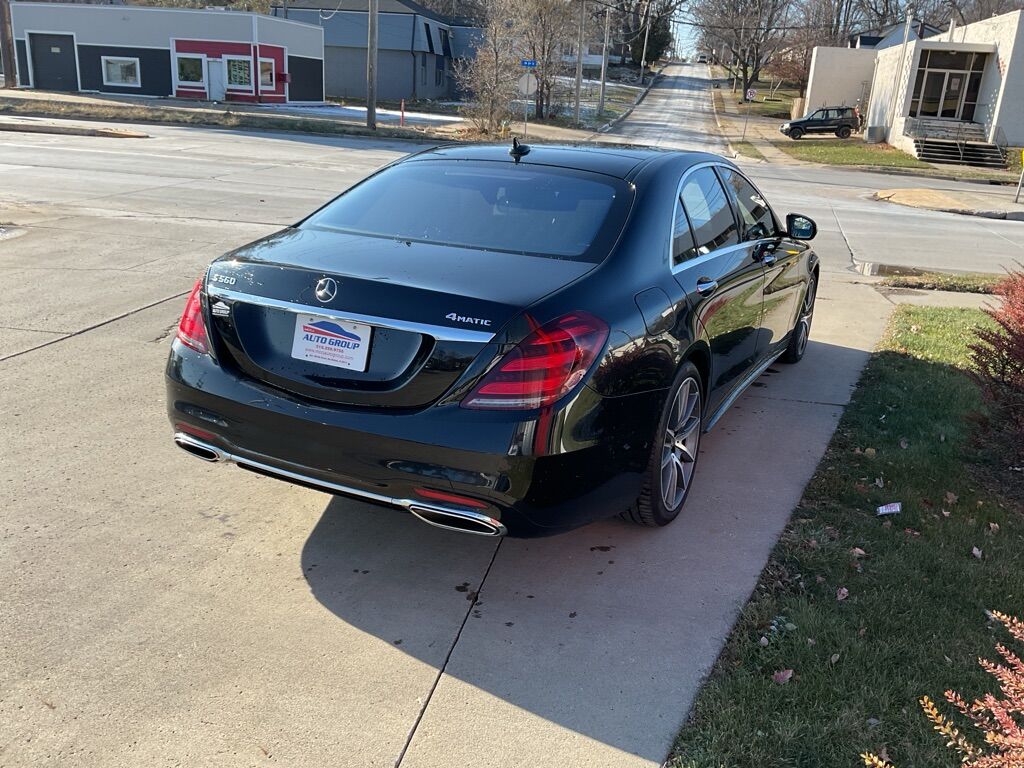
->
left=302, top=341, right=867, bottom=765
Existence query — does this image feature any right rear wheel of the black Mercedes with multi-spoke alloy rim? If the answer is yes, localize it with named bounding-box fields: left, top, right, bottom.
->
left=623, top=362, right=705, bottom=527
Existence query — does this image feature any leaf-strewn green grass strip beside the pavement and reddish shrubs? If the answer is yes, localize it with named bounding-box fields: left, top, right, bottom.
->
left=669, top=306, right=1024, bottom=768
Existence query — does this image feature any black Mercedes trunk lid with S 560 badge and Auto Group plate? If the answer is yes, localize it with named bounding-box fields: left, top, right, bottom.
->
left=207, top=228, right=595, bottom=408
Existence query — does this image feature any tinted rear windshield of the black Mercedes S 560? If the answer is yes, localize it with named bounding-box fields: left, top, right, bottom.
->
left=303, top=160, right=631, bottom=262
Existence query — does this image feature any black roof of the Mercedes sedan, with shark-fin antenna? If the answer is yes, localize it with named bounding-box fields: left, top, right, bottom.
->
left=408, top=143, right=729, bottom=179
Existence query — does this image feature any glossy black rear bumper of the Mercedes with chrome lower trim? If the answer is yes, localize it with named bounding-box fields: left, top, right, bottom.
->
left=167, top=343, right=664, bottom=537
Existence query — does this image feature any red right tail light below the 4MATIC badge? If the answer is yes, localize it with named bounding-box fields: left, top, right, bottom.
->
left=462, top=312, right=608, bottom=411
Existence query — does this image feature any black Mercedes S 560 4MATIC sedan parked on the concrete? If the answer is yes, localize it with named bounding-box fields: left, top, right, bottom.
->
left=167, top=145, right=818, bottom=537
